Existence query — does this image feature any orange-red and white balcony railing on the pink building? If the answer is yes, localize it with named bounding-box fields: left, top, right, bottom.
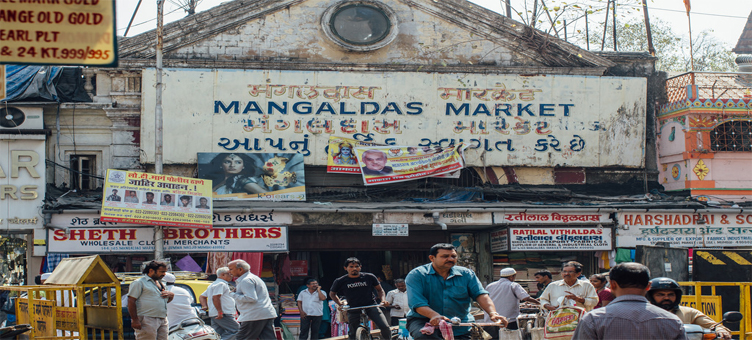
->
left=666, top=72, right=752, bottom=103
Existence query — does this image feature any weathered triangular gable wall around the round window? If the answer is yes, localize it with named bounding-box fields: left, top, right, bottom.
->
left=119, top=0, right=614, bottom=69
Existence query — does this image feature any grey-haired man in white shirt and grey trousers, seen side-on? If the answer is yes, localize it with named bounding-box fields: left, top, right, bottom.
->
left=227, top=260, right=277, bottom=340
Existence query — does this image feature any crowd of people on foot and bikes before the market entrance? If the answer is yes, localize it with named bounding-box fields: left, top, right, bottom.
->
left=128, top=243, right=731, bottom=340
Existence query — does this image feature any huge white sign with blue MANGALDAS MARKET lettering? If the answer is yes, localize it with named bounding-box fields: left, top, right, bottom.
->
left=141, top=69, right=646, bottom=167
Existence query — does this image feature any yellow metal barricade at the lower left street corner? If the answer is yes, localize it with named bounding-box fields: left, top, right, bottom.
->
left=0, top=284, right=123, bottom=340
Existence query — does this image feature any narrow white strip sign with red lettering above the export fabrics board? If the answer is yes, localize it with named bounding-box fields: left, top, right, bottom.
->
left=494, top=211, right=611, bottom=225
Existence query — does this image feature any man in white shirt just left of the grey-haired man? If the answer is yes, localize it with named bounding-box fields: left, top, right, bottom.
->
left=198, top=267, right=240, bottom=340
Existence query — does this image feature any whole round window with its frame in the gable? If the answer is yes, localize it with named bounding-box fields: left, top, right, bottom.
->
left=322, top=1, right=397, bottom=51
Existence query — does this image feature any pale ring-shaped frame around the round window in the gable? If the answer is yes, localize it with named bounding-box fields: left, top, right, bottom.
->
left=321, top=1, right=398, bottom=52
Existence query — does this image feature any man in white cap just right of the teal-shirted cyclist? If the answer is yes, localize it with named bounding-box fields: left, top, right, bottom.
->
left=485, top=268, right=540, bottom=339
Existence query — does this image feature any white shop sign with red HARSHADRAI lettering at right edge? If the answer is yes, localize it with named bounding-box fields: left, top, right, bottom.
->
left=616, top=211, right=752, bottom=248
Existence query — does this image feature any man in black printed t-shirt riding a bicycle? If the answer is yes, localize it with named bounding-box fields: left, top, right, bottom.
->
left=329, top=257, right=391, bottom=339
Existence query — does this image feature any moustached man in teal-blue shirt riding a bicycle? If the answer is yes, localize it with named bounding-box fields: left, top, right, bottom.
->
left=405, top=243, right=507, bottom=339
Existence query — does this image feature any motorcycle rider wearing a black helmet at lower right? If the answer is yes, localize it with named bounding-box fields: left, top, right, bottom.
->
left=645, top=277, right=731, bottom=340
